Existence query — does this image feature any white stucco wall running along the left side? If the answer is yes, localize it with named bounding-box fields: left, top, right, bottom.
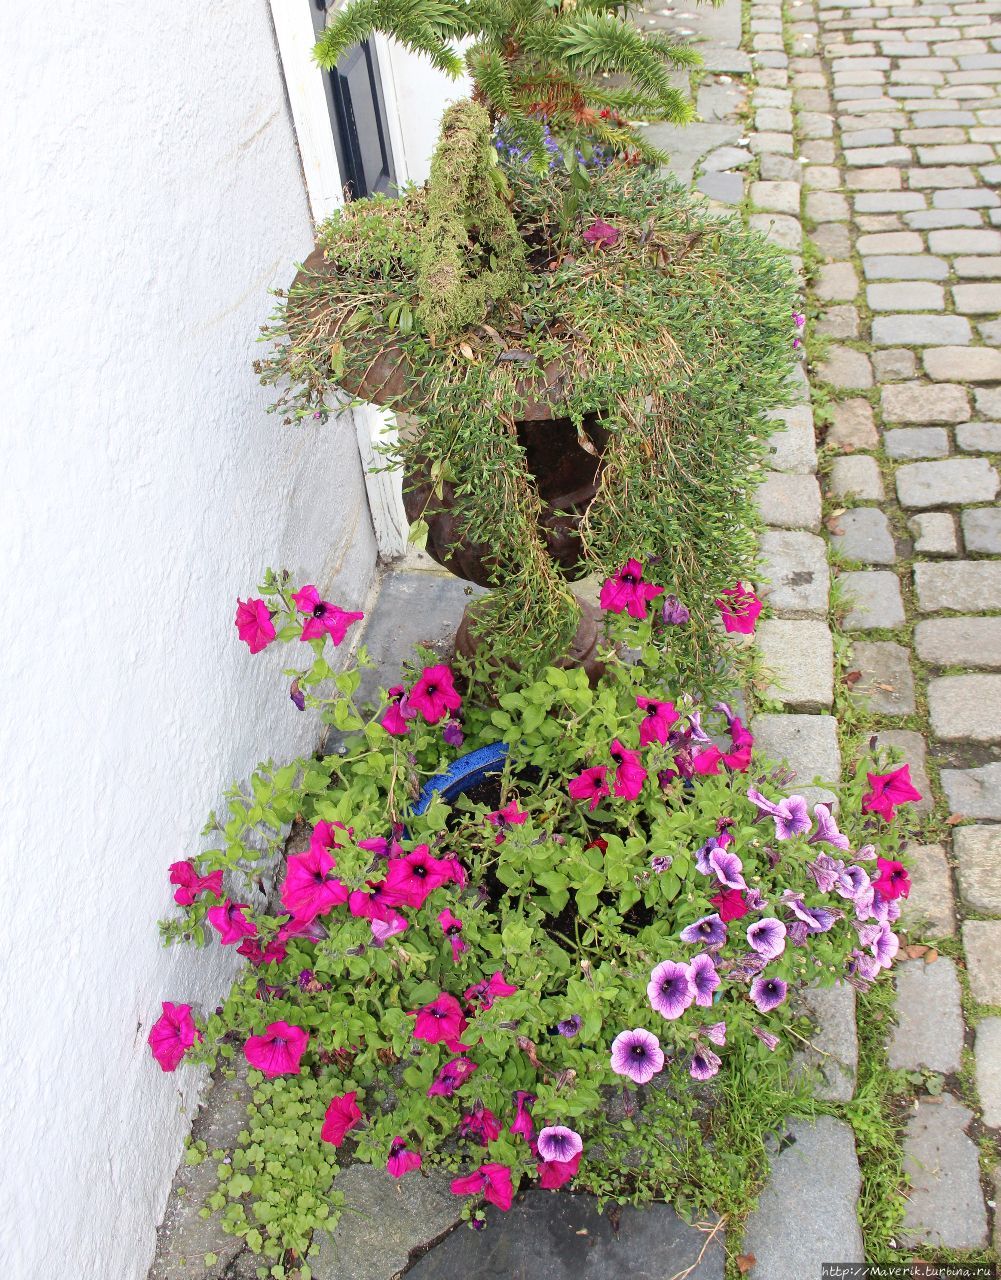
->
left=0, top=0, right=375, bottom=1280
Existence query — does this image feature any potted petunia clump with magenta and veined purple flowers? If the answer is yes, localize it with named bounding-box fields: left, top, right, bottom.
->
left=150, top=562, right=917, bottom=1280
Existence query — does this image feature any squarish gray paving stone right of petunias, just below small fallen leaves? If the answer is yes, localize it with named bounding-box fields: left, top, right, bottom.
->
left=887, top=956, right=965, bottom=1075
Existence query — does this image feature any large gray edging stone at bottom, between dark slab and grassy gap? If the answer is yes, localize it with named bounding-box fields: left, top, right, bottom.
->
left=742, top=1116, right=864, bottom=1280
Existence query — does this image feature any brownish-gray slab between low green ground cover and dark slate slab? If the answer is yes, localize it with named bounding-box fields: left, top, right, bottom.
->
left=310, top=1165, right=472, bottom=1280
